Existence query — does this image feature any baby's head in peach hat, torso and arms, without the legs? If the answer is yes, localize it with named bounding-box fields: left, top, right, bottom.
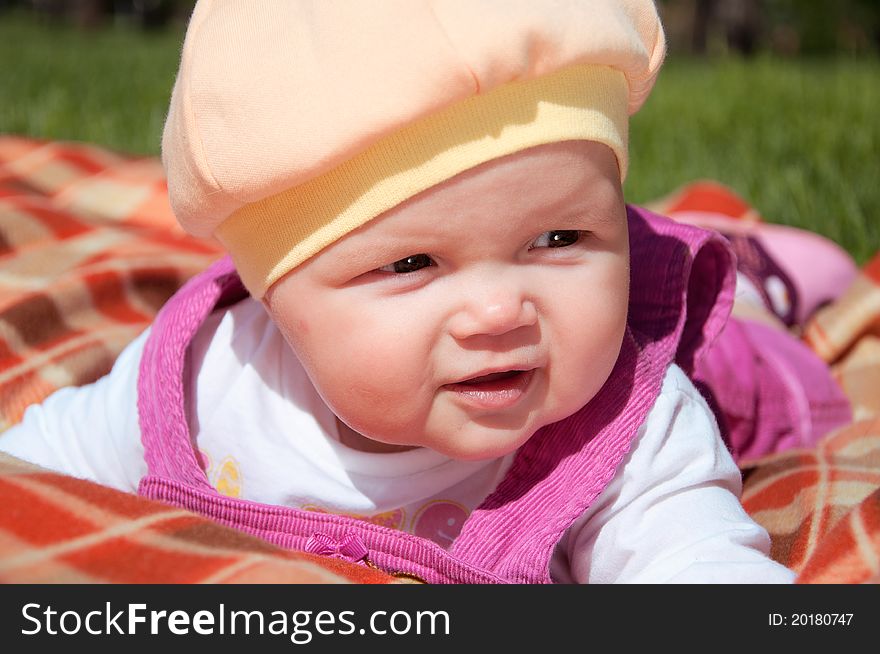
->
left=0, top=0, right=793, bottom=583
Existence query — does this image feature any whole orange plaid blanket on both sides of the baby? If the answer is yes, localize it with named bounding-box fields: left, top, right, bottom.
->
left=0, top=136, right=880, bottom=583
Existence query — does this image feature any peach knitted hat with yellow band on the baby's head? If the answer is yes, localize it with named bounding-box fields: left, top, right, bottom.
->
left=162, top=0, right=665, bottom=298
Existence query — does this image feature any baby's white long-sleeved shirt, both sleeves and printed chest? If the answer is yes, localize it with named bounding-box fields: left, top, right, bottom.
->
left=0, top=300, right=794, bottom=583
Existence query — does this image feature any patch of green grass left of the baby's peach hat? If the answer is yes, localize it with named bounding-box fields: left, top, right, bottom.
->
left=0, top=13, right=183, bottom=154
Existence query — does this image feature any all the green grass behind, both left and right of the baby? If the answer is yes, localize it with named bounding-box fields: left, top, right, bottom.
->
left=0, top=13, right=880, bottom=263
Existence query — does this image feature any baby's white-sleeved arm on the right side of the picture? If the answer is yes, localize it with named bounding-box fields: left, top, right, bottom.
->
left=551, top=367, right=794, bottom=583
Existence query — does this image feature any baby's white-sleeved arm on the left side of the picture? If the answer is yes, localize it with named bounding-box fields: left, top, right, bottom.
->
left=0, top=332, right=148, bottom=491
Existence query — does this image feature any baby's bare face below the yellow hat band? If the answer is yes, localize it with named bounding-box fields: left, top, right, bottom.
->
left=265, top=142, right=629, bottom=459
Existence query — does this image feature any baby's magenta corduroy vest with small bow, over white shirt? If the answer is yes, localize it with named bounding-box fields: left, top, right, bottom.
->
left=138, top=207, right=734, bottom=583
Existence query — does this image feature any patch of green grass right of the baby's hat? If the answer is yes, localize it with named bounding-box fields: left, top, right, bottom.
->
left=626, top=59, right=880, bottom=263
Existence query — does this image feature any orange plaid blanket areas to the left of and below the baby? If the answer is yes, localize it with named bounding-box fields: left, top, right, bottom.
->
left=0, top=136, right=391, bottom=583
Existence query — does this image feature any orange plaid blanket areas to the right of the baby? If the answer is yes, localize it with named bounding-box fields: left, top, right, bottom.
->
left=652, top=181, right=880, bottom=584
